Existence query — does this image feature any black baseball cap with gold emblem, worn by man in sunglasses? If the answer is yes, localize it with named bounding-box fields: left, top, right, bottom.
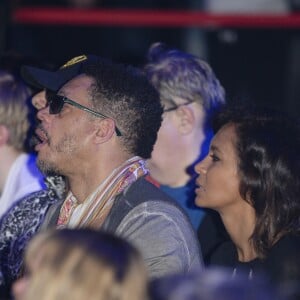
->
left=21, top=54, right=100, bottom=92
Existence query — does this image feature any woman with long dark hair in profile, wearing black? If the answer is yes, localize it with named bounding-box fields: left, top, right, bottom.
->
left=195, top=108, right=300, bottom=283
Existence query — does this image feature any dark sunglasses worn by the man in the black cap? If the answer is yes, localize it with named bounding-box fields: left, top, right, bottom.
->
left=46, top=90, right=122, bottom=136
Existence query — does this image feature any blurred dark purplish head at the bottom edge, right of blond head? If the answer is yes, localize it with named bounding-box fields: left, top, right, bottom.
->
left=149, top=267, right=280, bottom=300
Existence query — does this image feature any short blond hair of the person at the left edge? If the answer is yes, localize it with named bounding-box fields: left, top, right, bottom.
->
left=0, top=70, right=31, bottom=151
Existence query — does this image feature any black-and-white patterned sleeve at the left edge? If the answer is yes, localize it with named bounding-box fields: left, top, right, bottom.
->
left=0, top=176, right=65, bottom=289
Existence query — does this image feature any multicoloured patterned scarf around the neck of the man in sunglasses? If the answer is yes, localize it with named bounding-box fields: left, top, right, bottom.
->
left=57, top=156, right=148, bottom=229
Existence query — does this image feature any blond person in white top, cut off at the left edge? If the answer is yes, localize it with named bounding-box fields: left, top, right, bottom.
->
left=0, top=70, right=45, bottom=218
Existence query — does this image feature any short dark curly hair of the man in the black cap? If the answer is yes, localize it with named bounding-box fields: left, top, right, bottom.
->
left=82, top=59, right=163, bottom=159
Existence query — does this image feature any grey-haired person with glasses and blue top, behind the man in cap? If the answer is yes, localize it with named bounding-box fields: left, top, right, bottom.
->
left=144, top=43, right=226, bottom=259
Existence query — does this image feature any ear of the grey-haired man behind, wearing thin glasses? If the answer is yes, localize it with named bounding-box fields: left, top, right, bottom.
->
left=176, top=105, right=196, bottom=135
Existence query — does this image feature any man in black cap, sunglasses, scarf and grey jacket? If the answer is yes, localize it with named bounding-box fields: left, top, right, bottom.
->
left=23, top=55, right=201, bottom=277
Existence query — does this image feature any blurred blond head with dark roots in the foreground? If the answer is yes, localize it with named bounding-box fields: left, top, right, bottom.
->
left=13, top=229, right=147, bottom=300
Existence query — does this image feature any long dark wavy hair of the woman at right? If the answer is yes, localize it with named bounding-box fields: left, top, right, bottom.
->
left=214, top=106, right=300, bottom=258
